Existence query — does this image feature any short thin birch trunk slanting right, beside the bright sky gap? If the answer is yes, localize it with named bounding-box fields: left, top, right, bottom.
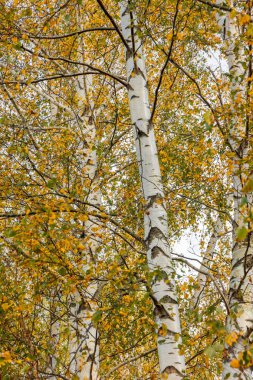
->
left=191, top=217, right=223, bottom=309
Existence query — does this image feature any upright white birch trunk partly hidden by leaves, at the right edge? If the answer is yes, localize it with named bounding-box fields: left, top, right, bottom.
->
left=217, top=1, right=253, bottom=380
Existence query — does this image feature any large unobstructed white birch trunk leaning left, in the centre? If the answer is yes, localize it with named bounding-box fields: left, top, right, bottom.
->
left=120, top=1, right=185, bottom=380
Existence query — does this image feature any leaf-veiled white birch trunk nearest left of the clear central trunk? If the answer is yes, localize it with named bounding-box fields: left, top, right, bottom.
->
left=69, top=12, right=101, bottom=380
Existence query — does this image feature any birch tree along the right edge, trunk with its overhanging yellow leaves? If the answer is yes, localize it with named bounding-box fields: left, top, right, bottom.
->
left=213, top=1, right=253, bottom=379
